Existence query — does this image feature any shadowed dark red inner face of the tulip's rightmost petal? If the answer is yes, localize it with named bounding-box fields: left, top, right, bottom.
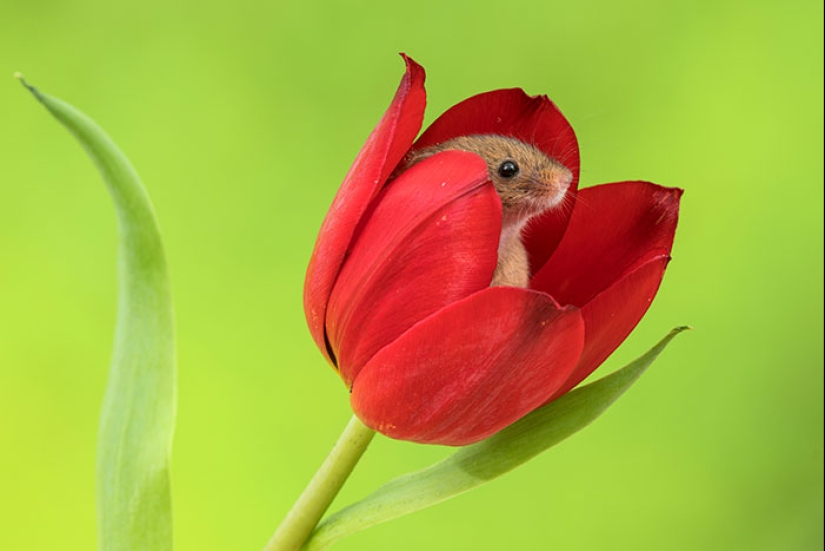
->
left=530, top=182, right=682, bottom=308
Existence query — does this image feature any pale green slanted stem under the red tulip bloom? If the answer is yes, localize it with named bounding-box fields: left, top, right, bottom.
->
left=264, top=415, right=375, bottom=551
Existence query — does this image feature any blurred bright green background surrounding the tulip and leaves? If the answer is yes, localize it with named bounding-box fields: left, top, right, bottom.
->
left=0, top=0, right=823, bottom=551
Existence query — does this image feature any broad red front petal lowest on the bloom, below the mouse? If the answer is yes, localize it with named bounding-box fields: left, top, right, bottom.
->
left=351, top=287, right=584, bottom=446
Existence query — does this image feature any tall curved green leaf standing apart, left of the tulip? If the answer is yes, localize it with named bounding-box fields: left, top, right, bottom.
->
left=17, top=75, right=175, bottom=551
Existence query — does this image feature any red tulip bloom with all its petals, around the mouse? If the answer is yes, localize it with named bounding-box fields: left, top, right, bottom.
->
left=304, top=56, right=682, bottom=445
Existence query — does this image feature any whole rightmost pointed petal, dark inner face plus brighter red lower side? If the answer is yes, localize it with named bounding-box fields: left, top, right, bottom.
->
left=531, top=182, right=682, bottom=399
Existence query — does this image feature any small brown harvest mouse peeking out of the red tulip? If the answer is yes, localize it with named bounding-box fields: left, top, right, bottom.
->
left=405, top=134, right=573, bottom=287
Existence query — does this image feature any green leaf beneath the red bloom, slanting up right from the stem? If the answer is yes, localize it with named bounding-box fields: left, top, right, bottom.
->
left=304, top=327, right=688, bottom=551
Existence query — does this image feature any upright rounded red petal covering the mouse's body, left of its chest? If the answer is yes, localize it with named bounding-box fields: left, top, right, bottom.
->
left=327, top=151, right=501, bottom=384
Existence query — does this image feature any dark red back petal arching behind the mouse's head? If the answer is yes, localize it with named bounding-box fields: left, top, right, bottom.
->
left=413, top=88, right=579, bottom=266
